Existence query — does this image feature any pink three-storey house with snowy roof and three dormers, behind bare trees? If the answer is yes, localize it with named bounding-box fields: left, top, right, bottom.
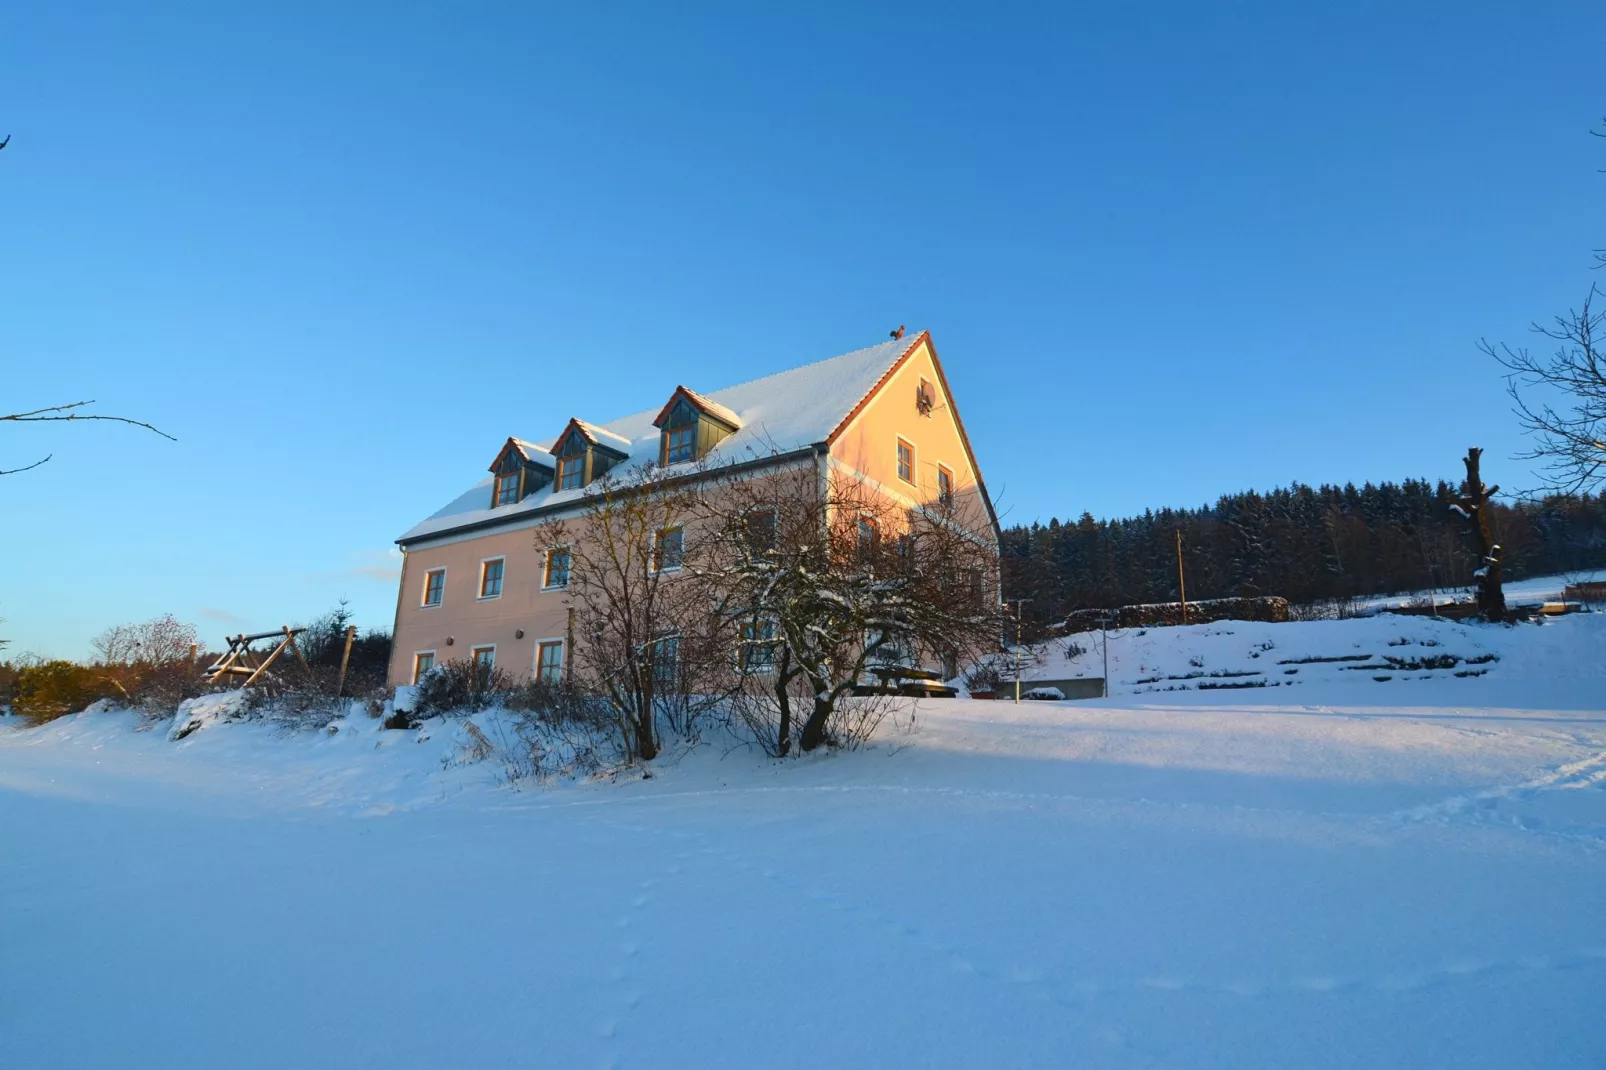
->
left=389, top=333, right=997, bottom=684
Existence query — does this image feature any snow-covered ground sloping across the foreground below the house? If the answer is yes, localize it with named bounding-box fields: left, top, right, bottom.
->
left=0, top=615, right=1606, bottom=1068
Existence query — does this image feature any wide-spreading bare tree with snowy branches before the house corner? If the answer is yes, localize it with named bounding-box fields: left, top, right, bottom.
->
left=699, top=459, right=1002, bottom=755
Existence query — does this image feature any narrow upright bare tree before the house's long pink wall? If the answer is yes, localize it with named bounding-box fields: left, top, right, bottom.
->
left=535, top=466, right=729, bottom=762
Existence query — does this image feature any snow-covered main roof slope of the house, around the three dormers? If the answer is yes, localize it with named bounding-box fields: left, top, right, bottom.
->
left=397, top=331, right=923, bottom=543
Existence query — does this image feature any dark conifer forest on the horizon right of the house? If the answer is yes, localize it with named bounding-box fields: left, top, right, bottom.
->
left=1004, top=480, right=1606, bottom=623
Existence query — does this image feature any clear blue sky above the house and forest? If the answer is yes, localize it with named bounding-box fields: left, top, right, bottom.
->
left=0, top=3, right=1606, bottom=655
